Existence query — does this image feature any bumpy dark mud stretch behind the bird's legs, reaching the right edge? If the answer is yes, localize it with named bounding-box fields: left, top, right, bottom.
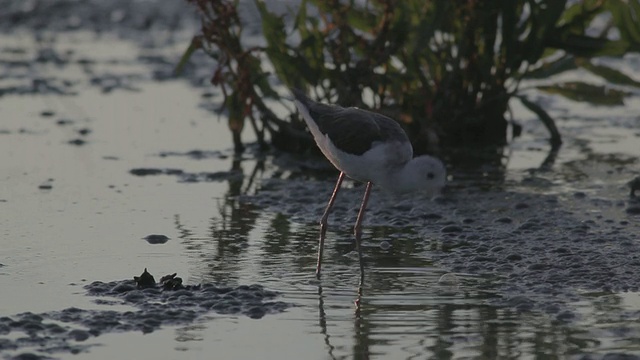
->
left=241, top=158, right=640, bottom=321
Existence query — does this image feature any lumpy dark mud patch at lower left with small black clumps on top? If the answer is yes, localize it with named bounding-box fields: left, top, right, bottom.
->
left=0, top=269, right=292, bottom=359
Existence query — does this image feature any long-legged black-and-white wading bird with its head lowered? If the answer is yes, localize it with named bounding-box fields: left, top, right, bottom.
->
left=291, top=89, right=446, bottom=287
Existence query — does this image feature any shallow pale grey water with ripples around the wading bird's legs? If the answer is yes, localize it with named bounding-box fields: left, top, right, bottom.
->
left=0, top=1, right=640, bottom=359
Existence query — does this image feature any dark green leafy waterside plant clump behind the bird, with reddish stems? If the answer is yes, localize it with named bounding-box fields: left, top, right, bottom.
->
left=179, top=0, right=640, bottom=153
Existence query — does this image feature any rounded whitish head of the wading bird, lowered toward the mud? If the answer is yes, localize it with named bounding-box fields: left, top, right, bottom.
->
left=401, top=155, right=447, bottom=196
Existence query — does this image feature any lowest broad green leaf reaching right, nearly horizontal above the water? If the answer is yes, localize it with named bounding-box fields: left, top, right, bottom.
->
left=538, top=81, right=629, bottom=106
